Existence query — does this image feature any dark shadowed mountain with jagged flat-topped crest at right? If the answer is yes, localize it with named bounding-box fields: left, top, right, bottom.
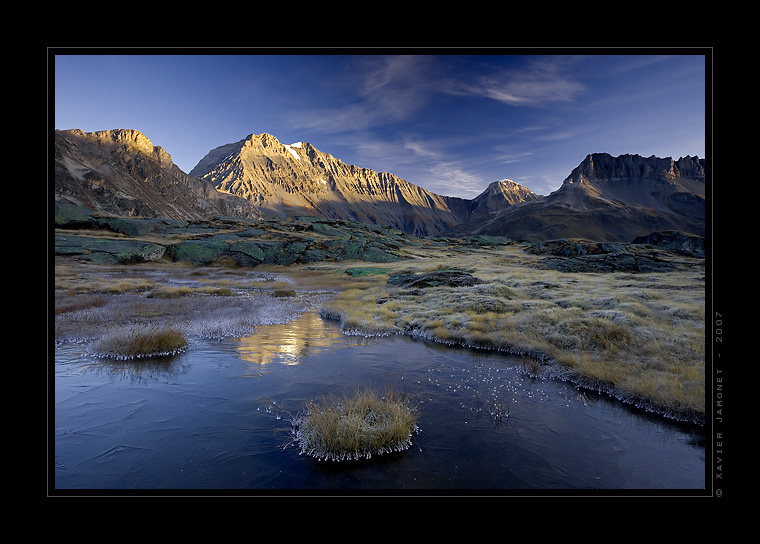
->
left=451, top=153, right=706, bottom=242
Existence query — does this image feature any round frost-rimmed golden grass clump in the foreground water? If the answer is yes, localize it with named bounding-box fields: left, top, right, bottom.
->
left=294, top=389, right=418, bottom=461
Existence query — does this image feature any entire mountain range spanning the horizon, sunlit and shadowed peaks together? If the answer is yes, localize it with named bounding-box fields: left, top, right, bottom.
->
left=54, top=129, right=705, bottom=242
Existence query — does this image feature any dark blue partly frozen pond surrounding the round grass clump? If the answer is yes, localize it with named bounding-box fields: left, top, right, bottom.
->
left=52, top=313, right=705, bottom=494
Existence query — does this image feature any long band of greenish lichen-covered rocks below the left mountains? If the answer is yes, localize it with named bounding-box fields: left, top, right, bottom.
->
left=54, top=202, right=410, bottom=267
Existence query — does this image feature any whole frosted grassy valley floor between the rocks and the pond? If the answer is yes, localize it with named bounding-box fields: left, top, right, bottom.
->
left=55, top=240, right=706, bottom=423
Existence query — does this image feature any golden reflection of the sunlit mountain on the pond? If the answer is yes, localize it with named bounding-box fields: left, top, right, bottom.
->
left=237, top=312, right=346, bottom=365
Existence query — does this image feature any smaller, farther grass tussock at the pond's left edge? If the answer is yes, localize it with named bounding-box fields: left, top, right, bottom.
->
left=96, top=327, right=188, bottom=359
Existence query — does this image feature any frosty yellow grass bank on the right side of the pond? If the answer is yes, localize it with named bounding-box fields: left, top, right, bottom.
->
left=314, top=246, right=705, bottom=420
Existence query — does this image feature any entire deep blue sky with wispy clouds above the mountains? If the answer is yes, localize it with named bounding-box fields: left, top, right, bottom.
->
left=50, top=49, right=709, bottom=198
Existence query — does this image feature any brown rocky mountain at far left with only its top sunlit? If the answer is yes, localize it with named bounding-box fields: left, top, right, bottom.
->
left=54, top=129, right=261, bottom=219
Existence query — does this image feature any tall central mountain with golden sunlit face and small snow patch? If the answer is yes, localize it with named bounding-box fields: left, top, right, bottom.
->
left=190, top=133, right=532, bottom=236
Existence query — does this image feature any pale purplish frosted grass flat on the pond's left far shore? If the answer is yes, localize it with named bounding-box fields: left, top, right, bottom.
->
left=55, top=264, right=334, bottom=346
